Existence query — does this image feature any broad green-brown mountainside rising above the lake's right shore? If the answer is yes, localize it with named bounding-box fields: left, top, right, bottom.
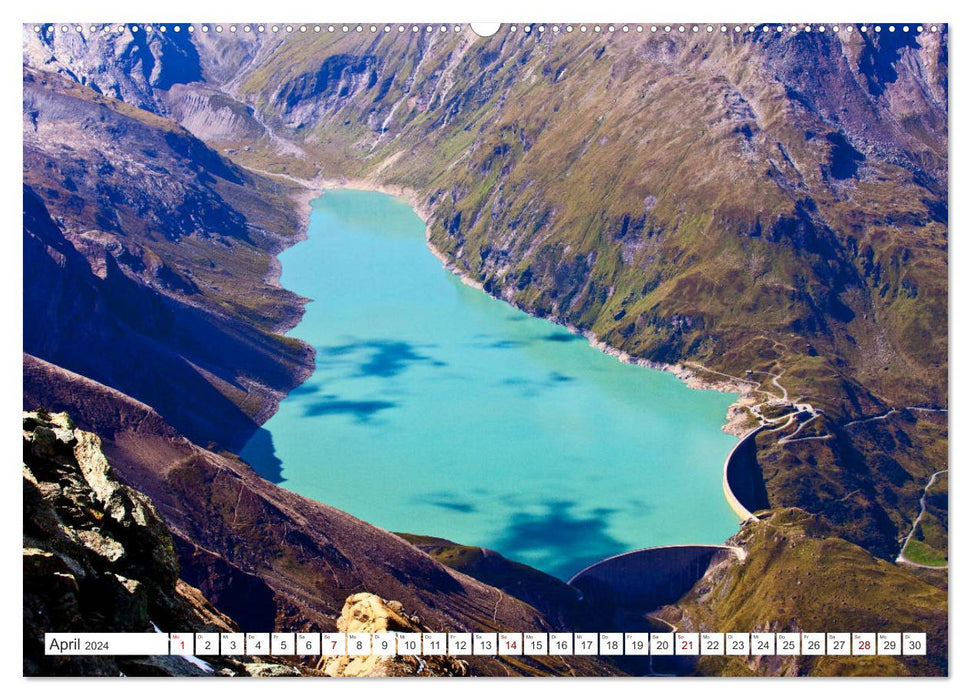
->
left=222, top=34, right=947, bottom=422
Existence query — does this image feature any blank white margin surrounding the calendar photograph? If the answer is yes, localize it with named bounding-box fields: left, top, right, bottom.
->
left=0, top=0, right=971, bottom=700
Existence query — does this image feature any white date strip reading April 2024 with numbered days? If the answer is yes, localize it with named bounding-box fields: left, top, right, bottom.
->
left=44, top=632, right=927, bottom=657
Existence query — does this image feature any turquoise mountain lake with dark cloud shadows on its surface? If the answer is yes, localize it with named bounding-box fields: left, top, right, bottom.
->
left=242, top=190, right=737, bottom=579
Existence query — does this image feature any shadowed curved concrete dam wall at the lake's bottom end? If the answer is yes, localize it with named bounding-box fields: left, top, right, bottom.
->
left=569, top=544, right=744, bottom=610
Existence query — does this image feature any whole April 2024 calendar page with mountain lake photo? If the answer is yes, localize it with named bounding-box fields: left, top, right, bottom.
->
left=19, top=0, right=950, bottom=690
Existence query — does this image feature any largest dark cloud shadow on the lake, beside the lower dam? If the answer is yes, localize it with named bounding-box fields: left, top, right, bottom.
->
left=488, top=500, right=632, bottom=581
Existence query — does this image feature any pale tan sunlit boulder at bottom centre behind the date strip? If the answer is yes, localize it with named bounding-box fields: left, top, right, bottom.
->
left=317, top=593, right=469, bottom=676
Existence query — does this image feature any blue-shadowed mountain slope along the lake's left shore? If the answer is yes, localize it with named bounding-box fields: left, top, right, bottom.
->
left=24, top=65, right=312, bottom=447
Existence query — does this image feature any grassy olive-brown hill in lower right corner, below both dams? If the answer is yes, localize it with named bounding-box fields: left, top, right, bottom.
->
left=659, top=509, right=948, bottom=676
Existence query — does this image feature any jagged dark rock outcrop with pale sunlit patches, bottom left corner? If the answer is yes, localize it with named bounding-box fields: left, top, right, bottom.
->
left=23, top=411, right=297, bottom=676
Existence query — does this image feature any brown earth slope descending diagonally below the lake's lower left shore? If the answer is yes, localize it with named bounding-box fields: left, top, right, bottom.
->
left=24, top=355, right=618, bottom=676
